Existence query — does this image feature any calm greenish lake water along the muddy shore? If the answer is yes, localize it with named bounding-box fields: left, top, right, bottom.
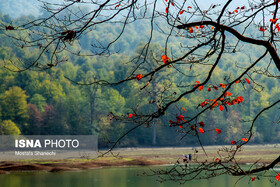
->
left=0, top=167, right=280, bottom=187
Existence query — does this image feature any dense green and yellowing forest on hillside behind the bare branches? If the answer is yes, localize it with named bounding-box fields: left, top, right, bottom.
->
left=0, top=6, right=280, bottom=146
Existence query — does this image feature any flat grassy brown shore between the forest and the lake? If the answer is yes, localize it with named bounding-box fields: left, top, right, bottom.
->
left=0, top=144, right=279, bottom=174
